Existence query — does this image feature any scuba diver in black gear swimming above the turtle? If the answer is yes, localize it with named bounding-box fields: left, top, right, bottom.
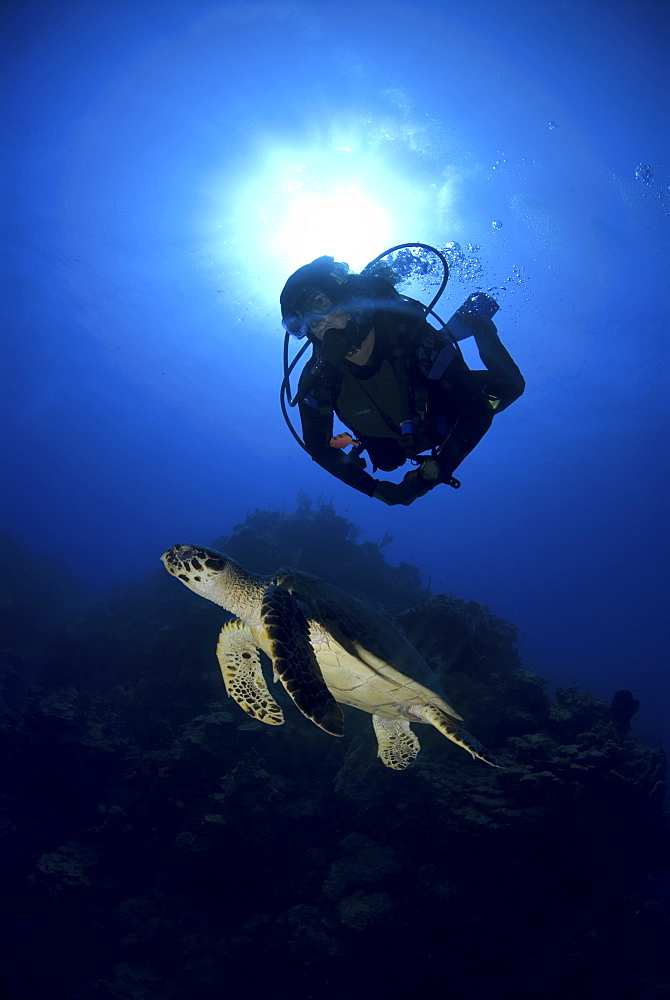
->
left=280, top=244, right=525, bottom=505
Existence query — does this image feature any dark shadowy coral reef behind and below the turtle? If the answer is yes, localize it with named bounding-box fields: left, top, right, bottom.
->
left=0, top=508, right=670, bottom=1000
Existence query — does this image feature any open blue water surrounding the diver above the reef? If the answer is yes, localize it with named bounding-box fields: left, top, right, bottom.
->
left=0, top=0, right=670, bottom=746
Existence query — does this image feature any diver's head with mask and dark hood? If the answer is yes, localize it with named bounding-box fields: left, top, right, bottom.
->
left=279, top=256, right=354, bottom=340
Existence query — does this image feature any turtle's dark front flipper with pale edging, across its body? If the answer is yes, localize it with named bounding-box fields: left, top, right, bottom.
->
left=261, top=584, right=344, bottom=736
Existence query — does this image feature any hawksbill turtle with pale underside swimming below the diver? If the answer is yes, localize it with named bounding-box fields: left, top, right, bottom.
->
left=161, top=545, right=498, bottom=770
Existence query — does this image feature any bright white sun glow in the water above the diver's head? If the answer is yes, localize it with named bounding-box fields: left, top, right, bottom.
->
left=211, top=136, right=450, bottom=275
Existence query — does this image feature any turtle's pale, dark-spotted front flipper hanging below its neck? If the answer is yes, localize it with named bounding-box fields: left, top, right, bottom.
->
left=216, top=618, right=284, bottom=726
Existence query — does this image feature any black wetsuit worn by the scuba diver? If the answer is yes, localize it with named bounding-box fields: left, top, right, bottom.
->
left=298, top=296, right=525, bottom=502
